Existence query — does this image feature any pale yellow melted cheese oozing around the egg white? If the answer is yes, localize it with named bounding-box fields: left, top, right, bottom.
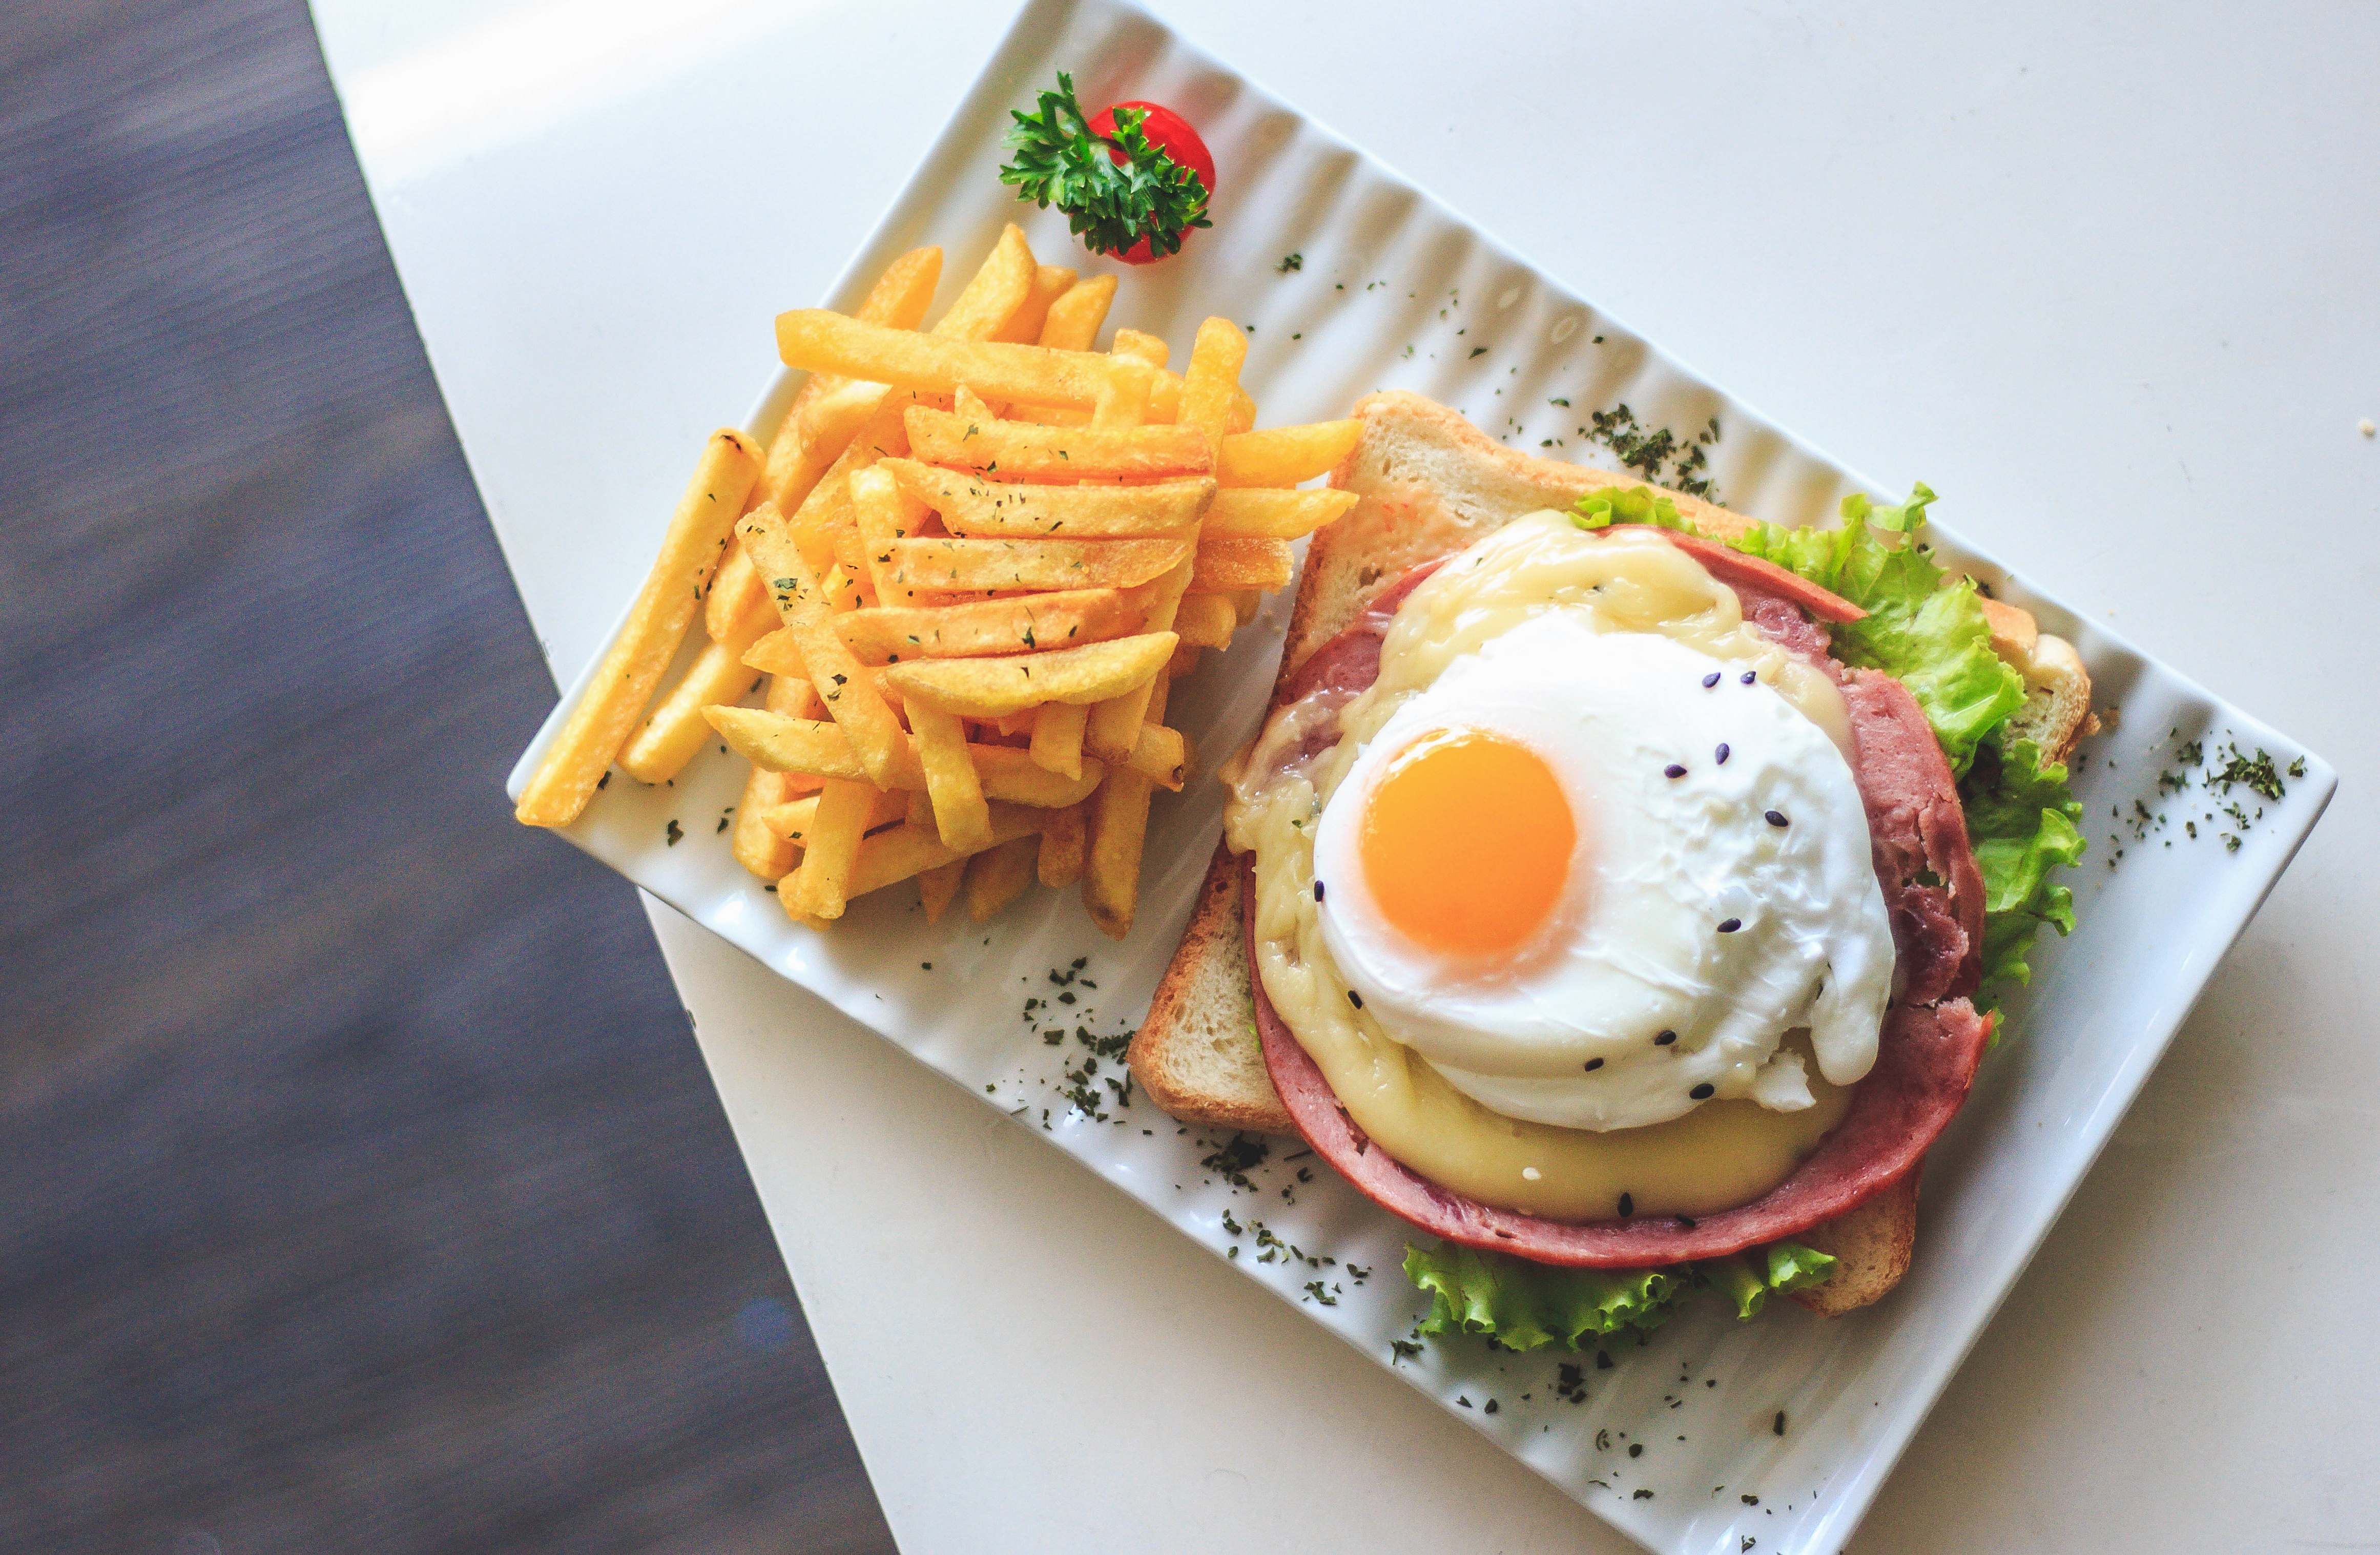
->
left=1226, top=512, right=1849, bottom=1221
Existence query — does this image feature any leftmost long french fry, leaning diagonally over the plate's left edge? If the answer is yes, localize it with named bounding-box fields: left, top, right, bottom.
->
left=514, top=429, right=764, bottom=826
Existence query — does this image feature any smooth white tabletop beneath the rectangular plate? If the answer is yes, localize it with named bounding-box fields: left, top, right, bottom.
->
left=314, top=0, right=2380, bottom=1552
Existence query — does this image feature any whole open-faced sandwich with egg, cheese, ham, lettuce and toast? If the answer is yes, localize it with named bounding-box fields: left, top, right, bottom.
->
left=1130, top=393, right=2089, bottom=1348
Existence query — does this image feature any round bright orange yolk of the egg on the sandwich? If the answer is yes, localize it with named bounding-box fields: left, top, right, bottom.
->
left=1357, top=729, right=1578, bottom=955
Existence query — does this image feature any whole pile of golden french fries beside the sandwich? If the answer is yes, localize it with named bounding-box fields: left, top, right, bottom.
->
left=516, top=226, right=1359, bottom=938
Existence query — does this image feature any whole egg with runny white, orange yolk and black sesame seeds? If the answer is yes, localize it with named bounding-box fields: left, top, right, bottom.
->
left=1314, top=607, right=1894, bottom=1131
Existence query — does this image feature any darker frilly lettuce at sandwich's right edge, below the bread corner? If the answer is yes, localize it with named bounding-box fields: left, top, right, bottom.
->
left=1959, top=740, right=2082, bottom=986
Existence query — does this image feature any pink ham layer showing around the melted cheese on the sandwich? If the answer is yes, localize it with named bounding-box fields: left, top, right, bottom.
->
left=1243, top=531, right=1992, bottom=1269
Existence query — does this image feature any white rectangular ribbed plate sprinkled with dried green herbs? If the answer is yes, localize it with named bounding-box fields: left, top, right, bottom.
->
left=512, top=0, right=2335, bottom=1555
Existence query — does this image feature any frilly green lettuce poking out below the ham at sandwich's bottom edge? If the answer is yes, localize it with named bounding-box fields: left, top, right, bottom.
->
left=1404, top=1243, right=1835, bottom=1350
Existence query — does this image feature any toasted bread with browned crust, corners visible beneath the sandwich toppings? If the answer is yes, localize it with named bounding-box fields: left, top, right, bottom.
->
left=1128, top=390, right=2089, bottom=1315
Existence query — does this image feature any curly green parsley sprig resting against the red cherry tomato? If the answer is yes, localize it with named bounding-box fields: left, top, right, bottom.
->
left=1000, top=71, right=1211, bottom=257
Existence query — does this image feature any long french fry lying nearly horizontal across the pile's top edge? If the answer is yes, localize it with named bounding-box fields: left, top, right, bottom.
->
left=776, top=307, right=1114, bottom=409
